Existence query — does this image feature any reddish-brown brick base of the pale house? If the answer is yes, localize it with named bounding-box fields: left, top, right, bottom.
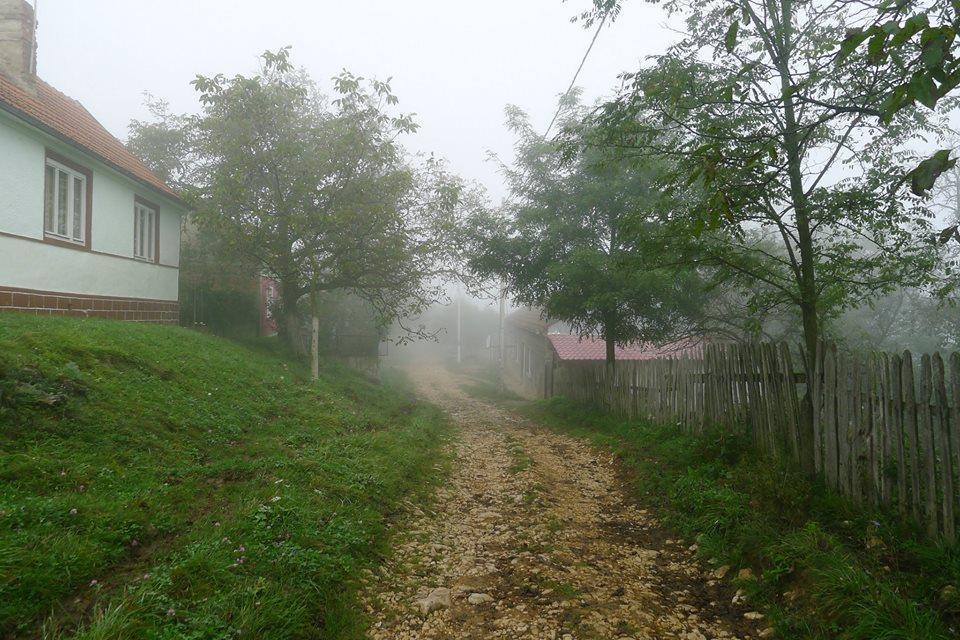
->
left=0, top=286, right=180, bottom=324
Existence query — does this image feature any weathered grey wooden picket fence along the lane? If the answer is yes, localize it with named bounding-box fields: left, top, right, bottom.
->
left=547, top=343, right=960, bottom=542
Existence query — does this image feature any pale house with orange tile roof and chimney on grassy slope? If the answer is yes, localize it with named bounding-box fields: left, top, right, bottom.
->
left=0, top=0, right=186, bottom=322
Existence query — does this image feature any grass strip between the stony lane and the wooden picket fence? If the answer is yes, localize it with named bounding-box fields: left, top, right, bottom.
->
left=522, top=399, right=960, bottom=640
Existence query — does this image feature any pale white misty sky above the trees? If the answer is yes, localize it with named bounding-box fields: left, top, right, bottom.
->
left=38, top=0, right=676, bottom=199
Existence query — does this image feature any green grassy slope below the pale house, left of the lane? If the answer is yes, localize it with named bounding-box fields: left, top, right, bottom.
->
left=0, top=315, right=448, bottom=638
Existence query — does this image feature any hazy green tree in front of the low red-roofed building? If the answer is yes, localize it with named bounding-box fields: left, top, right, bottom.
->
left=471, top=96, right=702, bottom=365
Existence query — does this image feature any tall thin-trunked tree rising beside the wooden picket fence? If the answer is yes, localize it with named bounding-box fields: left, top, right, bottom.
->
left=576, top=0, right=937, bottom=380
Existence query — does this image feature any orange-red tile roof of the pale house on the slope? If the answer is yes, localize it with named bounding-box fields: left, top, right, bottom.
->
left=0, top=75, right=180, bottom=205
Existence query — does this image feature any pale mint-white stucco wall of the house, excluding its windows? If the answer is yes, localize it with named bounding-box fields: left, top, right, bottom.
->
left=0, top=112, right=183, bottom=301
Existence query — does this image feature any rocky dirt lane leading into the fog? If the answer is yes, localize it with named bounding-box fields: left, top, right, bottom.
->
left=364, top=368, right=769, bottom=640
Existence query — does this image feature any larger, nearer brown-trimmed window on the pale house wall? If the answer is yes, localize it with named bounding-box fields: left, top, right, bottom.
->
left=43, top=158, right=90, bottom=245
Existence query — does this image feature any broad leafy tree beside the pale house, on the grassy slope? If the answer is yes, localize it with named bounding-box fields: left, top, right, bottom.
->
left=180, top=50, right=468, bottom=344
